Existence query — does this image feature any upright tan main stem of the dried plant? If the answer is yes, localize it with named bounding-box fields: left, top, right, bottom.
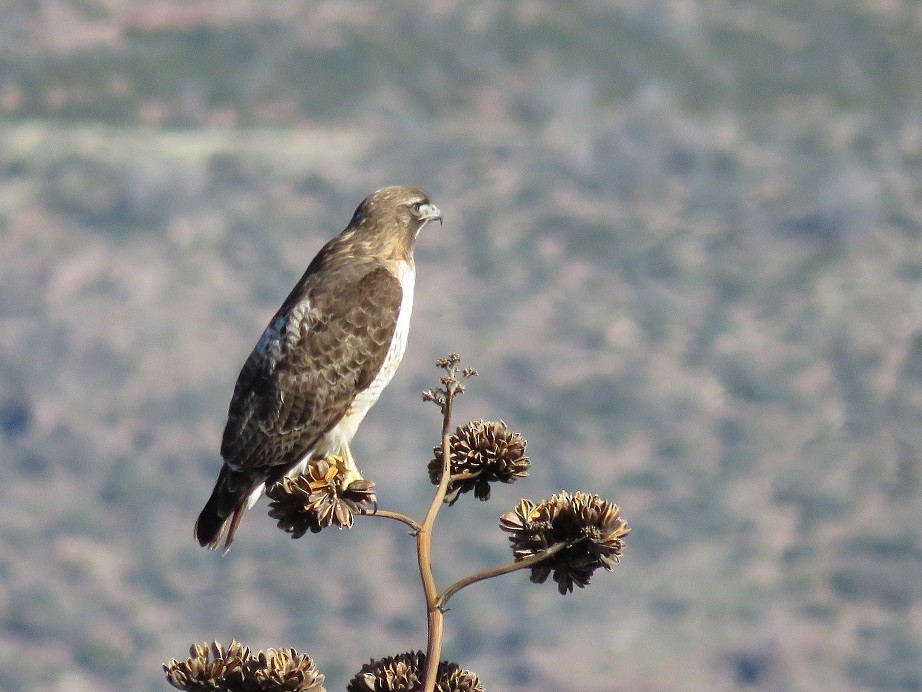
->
left=416, top=373, right=458, bottom=692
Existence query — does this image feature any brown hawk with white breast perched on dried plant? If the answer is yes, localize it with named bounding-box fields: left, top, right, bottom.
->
left=195, top=186, right=442, bottom=550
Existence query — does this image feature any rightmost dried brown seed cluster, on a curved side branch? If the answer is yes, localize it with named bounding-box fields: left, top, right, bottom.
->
left=500, top=492, right=630, bottom=594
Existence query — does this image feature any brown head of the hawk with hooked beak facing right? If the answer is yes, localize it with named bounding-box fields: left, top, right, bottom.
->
left=347, top=185, right=442, bottom=255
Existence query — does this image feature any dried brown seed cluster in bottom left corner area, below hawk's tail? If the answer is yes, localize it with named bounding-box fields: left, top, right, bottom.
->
left=163, top=641, right=325, bottom=692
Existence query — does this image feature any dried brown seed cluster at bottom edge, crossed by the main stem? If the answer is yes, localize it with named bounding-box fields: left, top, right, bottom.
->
left=346, top=651, right=483, bottom=692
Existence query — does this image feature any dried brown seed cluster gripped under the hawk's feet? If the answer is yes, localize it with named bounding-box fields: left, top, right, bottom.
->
left=266, top=457, right=376, bottom=538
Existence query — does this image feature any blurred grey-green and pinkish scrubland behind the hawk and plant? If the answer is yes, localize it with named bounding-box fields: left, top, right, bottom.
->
left=0, top=0, right=922, bottom=692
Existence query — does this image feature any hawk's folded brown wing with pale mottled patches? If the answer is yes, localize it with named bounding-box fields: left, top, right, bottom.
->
left=221, top=260, right=403, bottom=480
